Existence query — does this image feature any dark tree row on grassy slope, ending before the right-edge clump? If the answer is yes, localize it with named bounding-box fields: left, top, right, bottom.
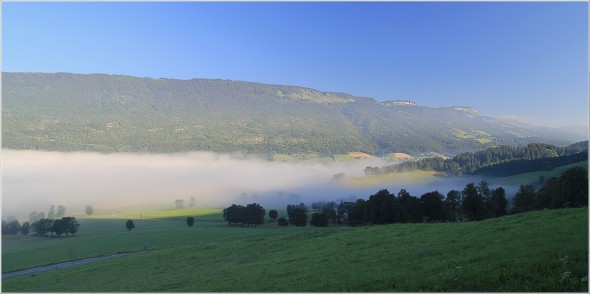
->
left=345, top=181, right=508, bottom=225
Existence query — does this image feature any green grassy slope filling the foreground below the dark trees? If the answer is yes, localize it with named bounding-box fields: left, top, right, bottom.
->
left=2, top=208, right=588, bottom=292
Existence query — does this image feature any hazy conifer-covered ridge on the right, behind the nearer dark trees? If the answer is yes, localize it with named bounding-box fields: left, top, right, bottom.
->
left=365, top=141, right=588, bottom=176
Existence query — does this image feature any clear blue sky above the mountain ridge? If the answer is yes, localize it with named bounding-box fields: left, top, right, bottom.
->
left=2, top=2, right=588, bottom=126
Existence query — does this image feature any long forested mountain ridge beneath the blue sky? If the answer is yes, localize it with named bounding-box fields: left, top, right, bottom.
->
left=2, top=73, right=586, bottom=155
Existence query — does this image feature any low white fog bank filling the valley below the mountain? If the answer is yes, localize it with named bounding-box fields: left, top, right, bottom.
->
left=2, top=150, right=508, bottom=220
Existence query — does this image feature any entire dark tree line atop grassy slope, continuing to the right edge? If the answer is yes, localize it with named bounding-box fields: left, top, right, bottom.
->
left=345, top=167, right=588, bottom=226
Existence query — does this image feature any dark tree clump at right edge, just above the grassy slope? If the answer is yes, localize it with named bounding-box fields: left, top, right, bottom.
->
left=512, top=167, right=588, bottom=213
